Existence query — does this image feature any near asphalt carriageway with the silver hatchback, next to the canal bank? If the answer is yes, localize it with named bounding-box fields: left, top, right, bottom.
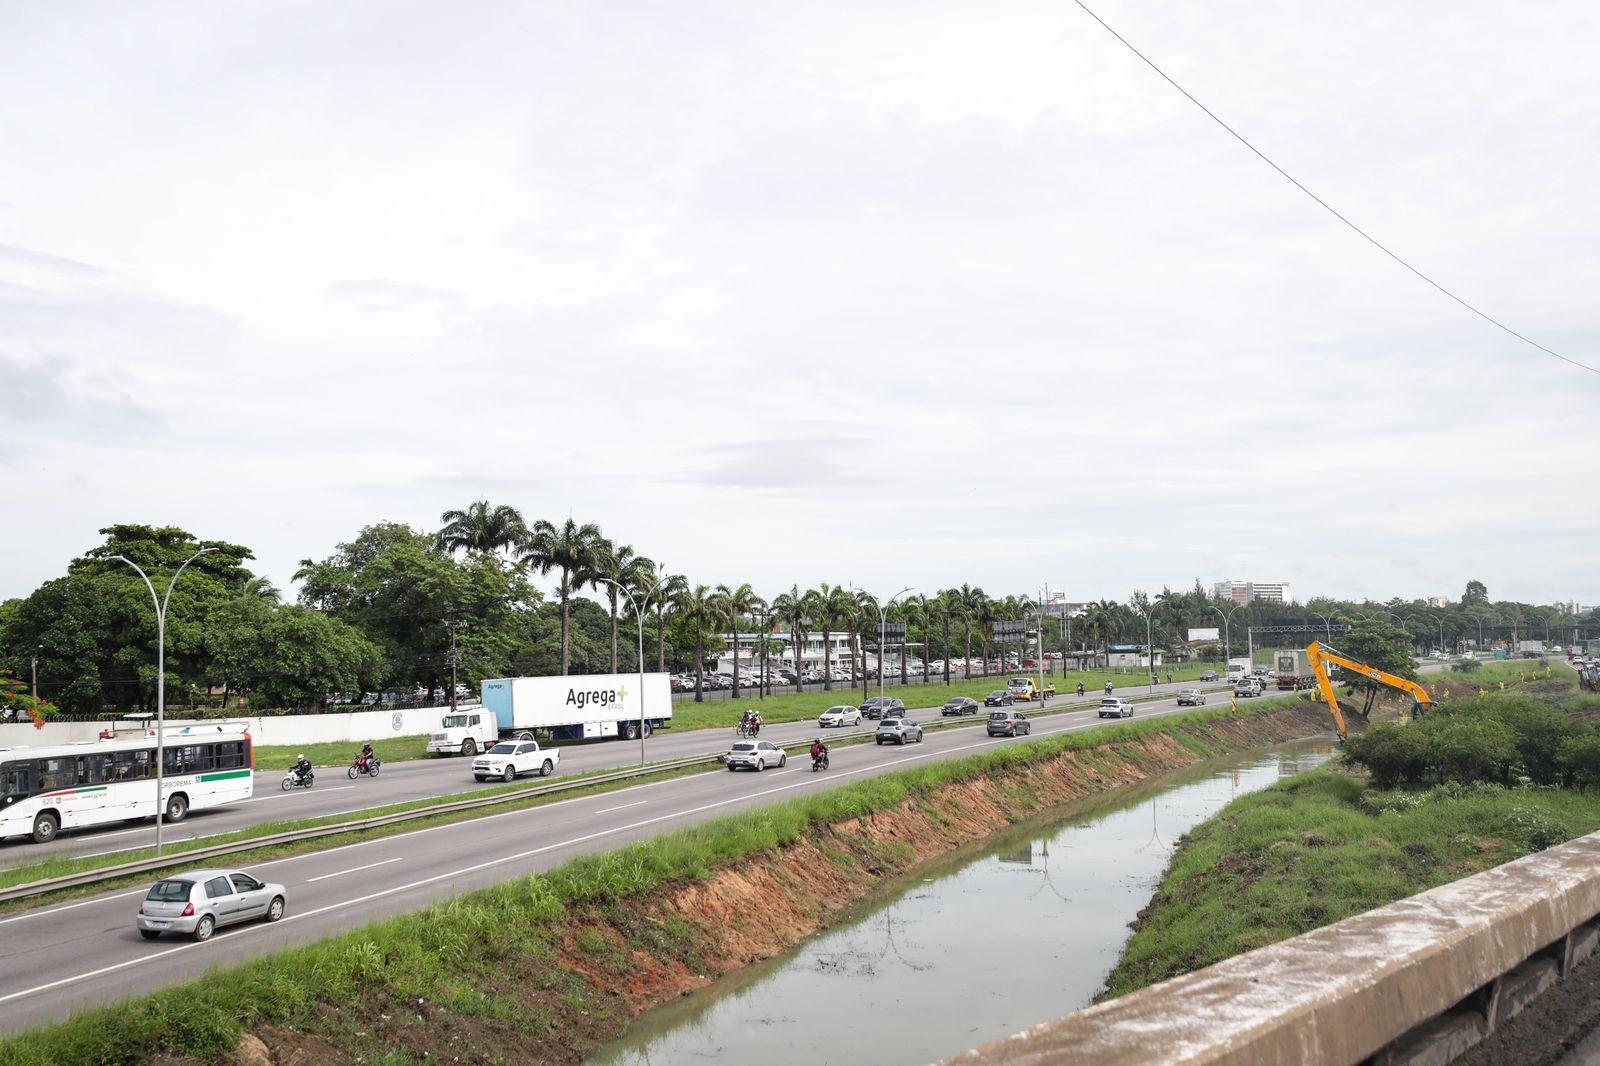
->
left=0, top=675, right=1299, bottom=1031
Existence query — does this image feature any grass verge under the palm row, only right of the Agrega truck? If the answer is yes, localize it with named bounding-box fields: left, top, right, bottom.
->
left=672, top=663, right=1221, bottom=731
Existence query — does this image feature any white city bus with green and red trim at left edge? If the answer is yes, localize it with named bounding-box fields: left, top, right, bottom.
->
left=0, top=725, right=256, bottom=844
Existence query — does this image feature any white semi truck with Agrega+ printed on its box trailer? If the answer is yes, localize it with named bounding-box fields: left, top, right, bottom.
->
left=427, top=674, right=672, bottom=755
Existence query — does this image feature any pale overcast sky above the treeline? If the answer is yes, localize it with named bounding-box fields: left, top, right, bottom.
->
left=0, top=0, right=1600, bottom=603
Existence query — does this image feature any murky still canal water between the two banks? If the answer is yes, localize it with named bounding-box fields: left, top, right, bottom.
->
left=594, top=741, right=1331, bottom=1066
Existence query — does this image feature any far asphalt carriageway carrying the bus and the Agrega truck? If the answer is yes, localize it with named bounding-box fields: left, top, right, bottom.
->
left=0, top=682, right=1226, bottom=869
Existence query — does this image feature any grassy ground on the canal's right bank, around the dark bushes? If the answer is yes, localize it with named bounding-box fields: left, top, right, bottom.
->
left=1106, top=663, right=1600, bottom=996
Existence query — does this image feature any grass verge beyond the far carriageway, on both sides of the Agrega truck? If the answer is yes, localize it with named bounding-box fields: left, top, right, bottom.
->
left=256, top=663, right=1218, bottom=770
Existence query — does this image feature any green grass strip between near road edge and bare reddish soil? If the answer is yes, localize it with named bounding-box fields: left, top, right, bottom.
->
left=0, top=697, right=1299, bottom=1066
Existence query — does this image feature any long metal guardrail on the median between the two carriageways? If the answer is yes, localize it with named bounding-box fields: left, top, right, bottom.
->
left=0, top=681, right=1248, bottom=903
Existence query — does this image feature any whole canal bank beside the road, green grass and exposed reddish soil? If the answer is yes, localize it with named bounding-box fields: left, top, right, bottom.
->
left=0, top=704, right=1322, bottom=1066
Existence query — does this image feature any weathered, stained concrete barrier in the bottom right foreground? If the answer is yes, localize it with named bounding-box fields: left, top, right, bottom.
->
left=950, top=834, right=1600, bottom=1066
